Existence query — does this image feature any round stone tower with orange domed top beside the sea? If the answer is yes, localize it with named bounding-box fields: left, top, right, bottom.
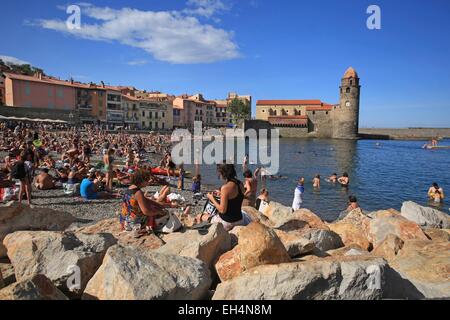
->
left=333, top=67, right=361, bottom=139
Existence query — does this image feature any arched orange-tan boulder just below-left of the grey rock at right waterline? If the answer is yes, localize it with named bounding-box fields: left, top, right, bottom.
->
left=367, top=211, right=428, bottom=248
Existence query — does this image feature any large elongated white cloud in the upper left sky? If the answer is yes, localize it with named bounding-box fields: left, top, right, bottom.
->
left=35, top=0, right=239, bottom=64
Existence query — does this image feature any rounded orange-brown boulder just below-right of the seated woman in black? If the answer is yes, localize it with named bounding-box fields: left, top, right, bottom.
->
left=216, top=222, right=291, bottom=281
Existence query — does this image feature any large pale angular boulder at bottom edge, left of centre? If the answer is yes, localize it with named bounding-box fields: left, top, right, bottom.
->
left=83, top=245, right=211, bottom=300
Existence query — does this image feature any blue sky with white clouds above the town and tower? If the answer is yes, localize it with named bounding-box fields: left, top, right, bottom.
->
left=0, top=0, right=450, bottom=128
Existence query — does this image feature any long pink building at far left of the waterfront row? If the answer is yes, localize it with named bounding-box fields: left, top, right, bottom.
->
left=4, top=73, right=76, bottom=110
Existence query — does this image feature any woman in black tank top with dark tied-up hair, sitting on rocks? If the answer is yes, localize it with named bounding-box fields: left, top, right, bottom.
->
left=208, top=164, right=244, bottom=231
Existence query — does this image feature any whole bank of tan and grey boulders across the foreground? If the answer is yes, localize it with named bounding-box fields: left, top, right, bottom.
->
left=0, top=202, right=450, bottom=300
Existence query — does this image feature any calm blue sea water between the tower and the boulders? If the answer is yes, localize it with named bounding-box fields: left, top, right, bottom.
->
left=184, top=139, right=450, bottom=221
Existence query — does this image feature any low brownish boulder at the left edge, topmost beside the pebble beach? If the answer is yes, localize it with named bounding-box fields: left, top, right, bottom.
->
left=0, top=201, right=75, bottom=258
